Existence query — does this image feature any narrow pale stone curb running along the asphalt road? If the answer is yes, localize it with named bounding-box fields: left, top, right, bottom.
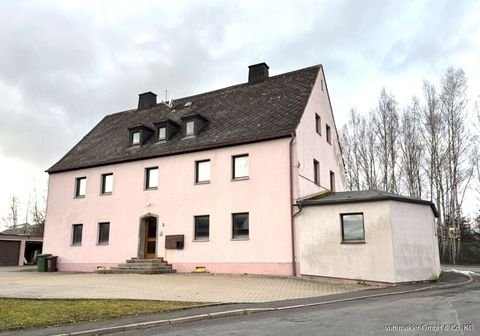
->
left=54, top=274, right=474, bottom=336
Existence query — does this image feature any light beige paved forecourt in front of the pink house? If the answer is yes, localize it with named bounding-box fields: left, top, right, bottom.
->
left=0, top=268, right=374, bottom=303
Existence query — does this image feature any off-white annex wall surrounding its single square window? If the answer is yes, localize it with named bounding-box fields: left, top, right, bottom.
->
left=299, top=202, right=395, bottom=282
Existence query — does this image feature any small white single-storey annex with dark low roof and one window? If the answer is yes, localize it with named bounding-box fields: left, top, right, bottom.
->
left=298, top=190, right=440, bottom=283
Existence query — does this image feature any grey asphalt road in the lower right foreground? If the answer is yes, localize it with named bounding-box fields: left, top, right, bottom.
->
left=115, top=276, right=480, bottom=336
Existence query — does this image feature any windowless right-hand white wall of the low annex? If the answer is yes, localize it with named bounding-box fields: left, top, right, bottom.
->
left=391, top=201, right=440, bottom=282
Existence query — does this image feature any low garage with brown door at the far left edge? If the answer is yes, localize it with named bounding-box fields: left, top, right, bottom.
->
left=0, top=233, right=43, bottom=266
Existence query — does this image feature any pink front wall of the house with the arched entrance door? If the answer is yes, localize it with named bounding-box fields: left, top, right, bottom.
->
left=44, top=138, right=292, bottom=275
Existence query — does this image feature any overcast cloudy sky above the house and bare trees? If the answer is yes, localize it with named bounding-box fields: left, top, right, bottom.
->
left=0, top=0, right=480, bottom=228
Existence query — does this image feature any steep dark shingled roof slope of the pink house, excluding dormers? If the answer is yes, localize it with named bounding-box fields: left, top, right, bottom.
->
left=47, top=65, right=321, bottom=173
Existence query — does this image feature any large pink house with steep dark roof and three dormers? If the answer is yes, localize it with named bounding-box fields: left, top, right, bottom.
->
left=43, top=63, right=344, bottom=275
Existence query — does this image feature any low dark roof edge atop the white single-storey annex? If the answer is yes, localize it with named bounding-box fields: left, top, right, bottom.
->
left=297, top=190, right=438, bottom=217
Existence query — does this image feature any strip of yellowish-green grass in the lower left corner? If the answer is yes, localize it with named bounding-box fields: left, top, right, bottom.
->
left=0, top=299, right=198, bottom=331
